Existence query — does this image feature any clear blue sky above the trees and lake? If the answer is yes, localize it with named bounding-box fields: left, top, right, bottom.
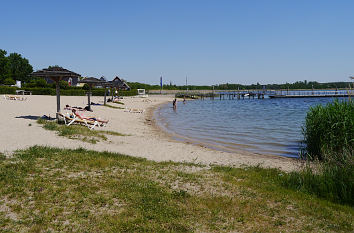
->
left=0, top=0, right=354, bottom=85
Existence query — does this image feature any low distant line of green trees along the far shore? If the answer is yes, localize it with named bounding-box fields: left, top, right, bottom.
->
left=128, top=80, right=353, bottom=90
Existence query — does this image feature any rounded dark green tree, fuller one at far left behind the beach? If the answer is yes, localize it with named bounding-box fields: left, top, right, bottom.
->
left=7, top=53, right=33, bottom=82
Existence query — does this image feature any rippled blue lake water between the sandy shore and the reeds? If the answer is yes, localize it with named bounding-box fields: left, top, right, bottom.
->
left=155, top=98, right=342, bottom=157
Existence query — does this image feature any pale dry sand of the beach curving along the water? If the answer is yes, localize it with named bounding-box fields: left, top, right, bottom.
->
left=0, top=96, right=297, bottom=171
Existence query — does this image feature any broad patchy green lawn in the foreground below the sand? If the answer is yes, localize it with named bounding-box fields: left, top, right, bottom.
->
left=0, top=146, right=354, bottom=232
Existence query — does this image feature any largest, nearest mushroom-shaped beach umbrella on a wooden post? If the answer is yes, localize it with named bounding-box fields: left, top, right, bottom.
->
left=30, top=66, right=81, bottom=119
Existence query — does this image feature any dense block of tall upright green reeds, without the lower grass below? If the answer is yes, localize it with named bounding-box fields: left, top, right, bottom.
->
left=303, top=100, right=354, bottom=160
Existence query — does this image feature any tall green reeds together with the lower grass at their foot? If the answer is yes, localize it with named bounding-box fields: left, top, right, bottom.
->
left=284, top=101, right=354, bottom=206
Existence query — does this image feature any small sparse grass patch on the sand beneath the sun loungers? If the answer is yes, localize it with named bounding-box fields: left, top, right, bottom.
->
left=37, top=118, right=127, bottom=144
